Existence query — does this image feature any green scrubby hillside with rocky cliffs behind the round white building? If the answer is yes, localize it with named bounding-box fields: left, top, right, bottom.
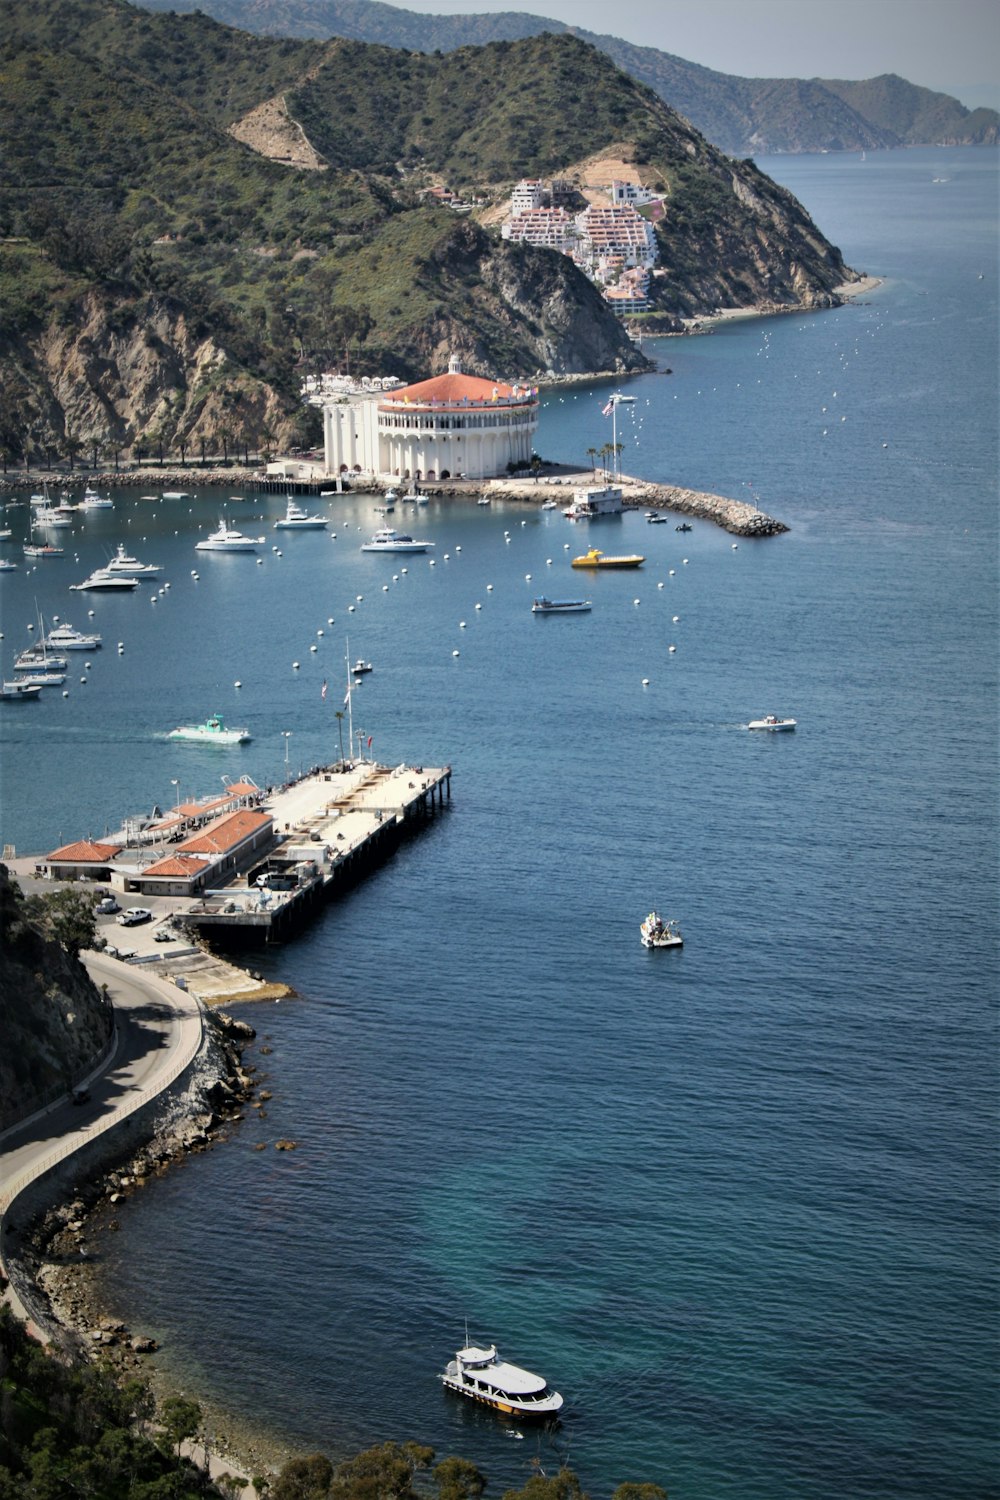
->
left=0, top=0, right=849, bottom=459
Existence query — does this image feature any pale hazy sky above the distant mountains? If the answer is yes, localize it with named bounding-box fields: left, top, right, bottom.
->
left=391, top=0, right=1000, bottom=108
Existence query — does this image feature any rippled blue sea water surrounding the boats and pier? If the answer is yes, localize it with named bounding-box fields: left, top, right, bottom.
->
left=0, top=150, right=1000, bottom=1500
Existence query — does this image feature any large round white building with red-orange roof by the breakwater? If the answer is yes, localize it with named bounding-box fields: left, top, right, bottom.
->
left=303, top=356, right=538, bottom=482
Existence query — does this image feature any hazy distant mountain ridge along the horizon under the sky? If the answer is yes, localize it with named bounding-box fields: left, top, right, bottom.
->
left=134, top=0, right=1000, bottom=156
